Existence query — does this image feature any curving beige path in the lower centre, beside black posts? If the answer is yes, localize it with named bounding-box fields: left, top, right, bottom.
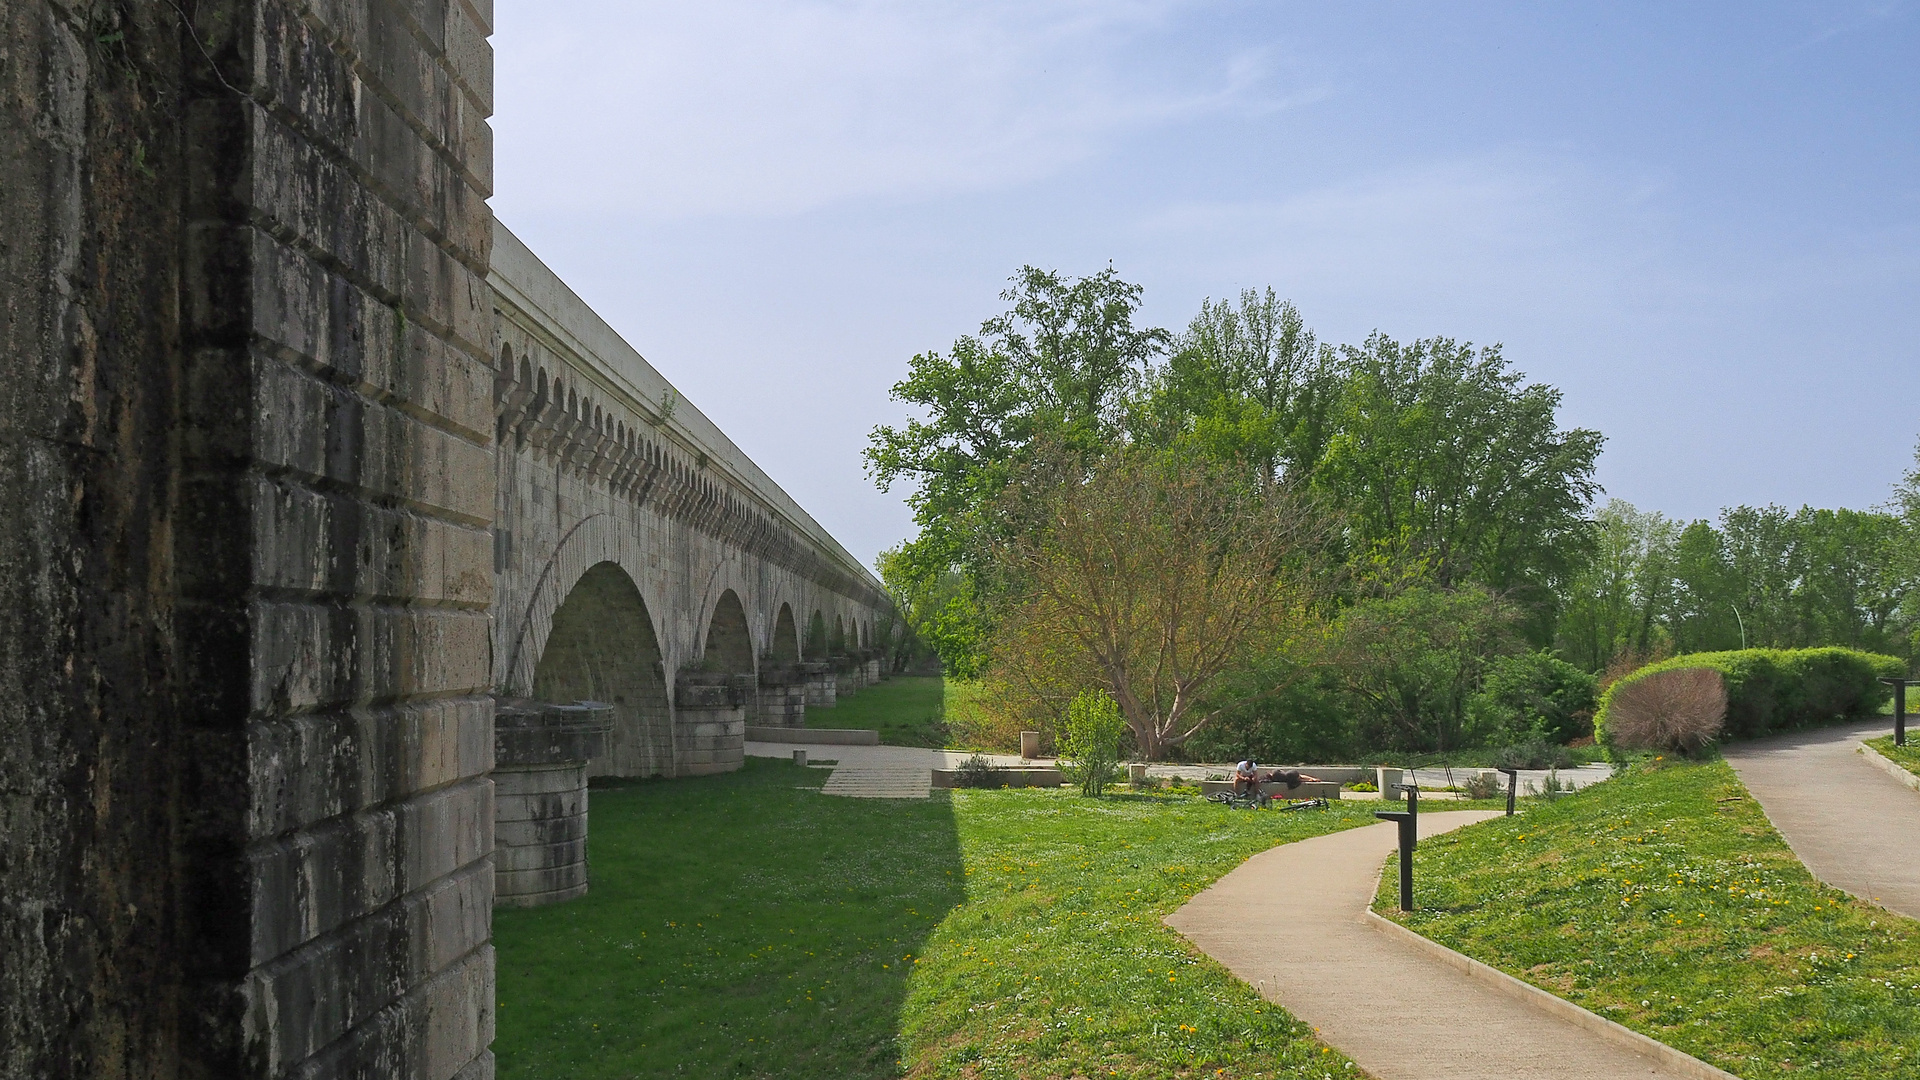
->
left=1167, top=811, right=1682, bottom=1080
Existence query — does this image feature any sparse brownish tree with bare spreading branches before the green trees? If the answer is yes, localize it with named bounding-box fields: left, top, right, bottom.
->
left=991, top=448, right=1325, bottom=759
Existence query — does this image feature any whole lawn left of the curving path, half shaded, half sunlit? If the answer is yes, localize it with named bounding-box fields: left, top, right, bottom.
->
left=493, top=759, right=1373, bottom=1080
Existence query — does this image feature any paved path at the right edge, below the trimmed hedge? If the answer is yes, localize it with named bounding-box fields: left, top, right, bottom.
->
left=1726, top=719, right=1920, bottom=919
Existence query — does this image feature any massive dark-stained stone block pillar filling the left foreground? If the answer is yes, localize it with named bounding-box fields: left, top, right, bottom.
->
left=0, top=0, right=493, bottom=1078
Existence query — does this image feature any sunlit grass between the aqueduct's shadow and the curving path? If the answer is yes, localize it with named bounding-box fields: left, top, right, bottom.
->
left=902, top=790, right=1373, bottom=1080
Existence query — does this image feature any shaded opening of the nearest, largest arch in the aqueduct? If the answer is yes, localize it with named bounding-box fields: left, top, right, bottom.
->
left=534, top=561, right=674, bottom=776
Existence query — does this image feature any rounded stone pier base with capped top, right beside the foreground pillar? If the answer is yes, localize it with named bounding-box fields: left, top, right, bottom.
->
left=493, top=700, right=614, bottom=907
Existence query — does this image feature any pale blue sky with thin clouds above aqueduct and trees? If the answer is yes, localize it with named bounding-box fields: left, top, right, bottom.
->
left=492, top=0, right=1920, bottom=561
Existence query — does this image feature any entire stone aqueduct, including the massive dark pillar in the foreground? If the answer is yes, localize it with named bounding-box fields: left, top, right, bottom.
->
left=0, top=0, right=889, bottom=1080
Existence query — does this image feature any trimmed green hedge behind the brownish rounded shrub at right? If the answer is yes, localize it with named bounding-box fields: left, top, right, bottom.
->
left=1594, top=648, right=1907, bottom=748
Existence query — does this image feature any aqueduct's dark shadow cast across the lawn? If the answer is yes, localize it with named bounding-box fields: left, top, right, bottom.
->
left=493, top=759, right=964, bottom=1080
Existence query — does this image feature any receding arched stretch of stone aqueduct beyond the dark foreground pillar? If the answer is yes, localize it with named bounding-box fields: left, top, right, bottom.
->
left=488, top=223, right=893, bottom=776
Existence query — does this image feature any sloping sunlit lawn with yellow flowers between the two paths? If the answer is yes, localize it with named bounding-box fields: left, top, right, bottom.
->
left=1375, top=761, right=1920, bottom=1080
